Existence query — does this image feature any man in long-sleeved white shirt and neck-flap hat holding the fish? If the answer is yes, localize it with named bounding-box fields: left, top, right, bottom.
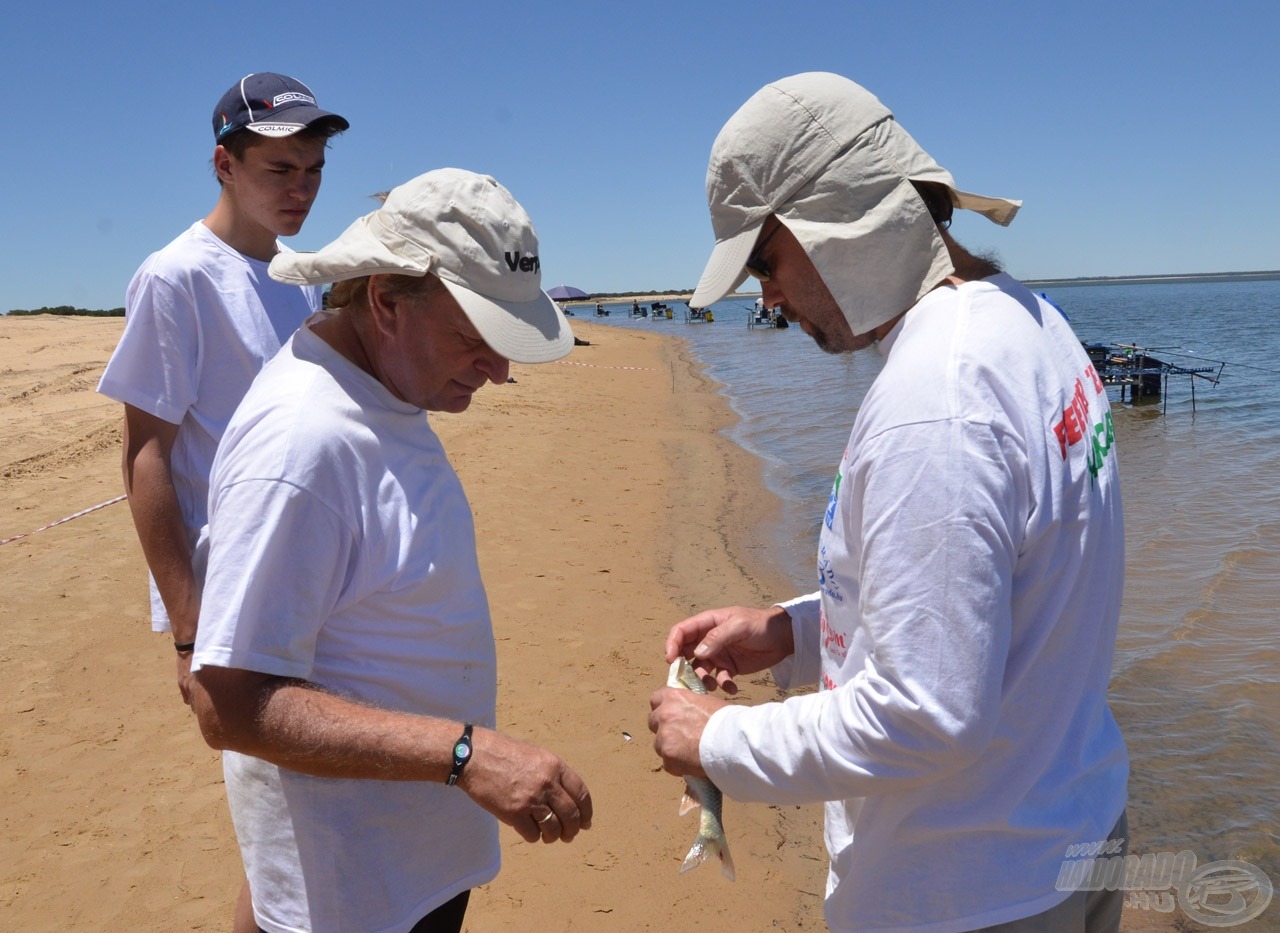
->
left=649, top=73, right=1128, bottom=933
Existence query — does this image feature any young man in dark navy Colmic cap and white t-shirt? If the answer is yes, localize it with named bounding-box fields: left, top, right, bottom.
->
left=99, top=73, right=348, bottom=701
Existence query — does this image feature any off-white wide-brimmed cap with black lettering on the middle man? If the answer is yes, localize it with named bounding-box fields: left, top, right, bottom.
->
left=269, top=169, right=573, bottom=363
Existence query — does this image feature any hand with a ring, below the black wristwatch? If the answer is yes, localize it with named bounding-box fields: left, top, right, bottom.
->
left=458, top=728, right=591, bottom=842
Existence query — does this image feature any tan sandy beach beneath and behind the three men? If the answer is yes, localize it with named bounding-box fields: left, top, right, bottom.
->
left=0, top=316, right=1175, bottom=933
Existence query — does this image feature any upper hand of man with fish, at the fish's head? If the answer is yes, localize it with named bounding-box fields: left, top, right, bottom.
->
left=659, top=605, right=795, bottom=691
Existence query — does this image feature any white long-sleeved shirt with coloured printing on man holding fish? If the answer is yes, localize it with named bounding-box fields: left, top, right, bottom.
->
left=700, top=275, right=1128, bottom=933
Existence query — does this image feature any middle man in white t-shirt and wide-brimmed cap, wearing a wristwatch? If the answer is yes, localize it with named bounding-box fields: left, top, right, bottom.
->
left=192, top=169, right=591, bottom=933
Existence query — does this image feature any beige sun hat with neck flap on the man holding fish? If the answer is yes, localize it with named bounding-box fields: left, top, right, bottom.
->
left=689, top=72, right=1021, bottom=334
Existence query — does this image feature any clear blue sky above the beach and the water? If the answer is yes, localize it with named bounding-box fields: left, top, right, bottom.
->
left=0, top=0, right=1280, bottom=311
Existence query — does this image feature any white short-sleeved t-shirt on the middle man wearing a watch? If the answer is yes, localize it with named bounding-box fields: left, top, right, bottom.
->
left=192, top=319, right=499, bottom=930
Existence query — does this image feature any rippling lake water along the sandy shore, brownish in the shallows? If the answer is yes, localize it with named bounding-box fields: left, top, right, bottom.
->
left=586, top=280, right=1280, bottom=895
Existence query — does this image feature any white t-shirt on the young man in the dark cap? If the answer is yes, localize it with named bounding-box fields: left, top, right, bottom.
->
left=97, top=221, right=323, bottom=631
